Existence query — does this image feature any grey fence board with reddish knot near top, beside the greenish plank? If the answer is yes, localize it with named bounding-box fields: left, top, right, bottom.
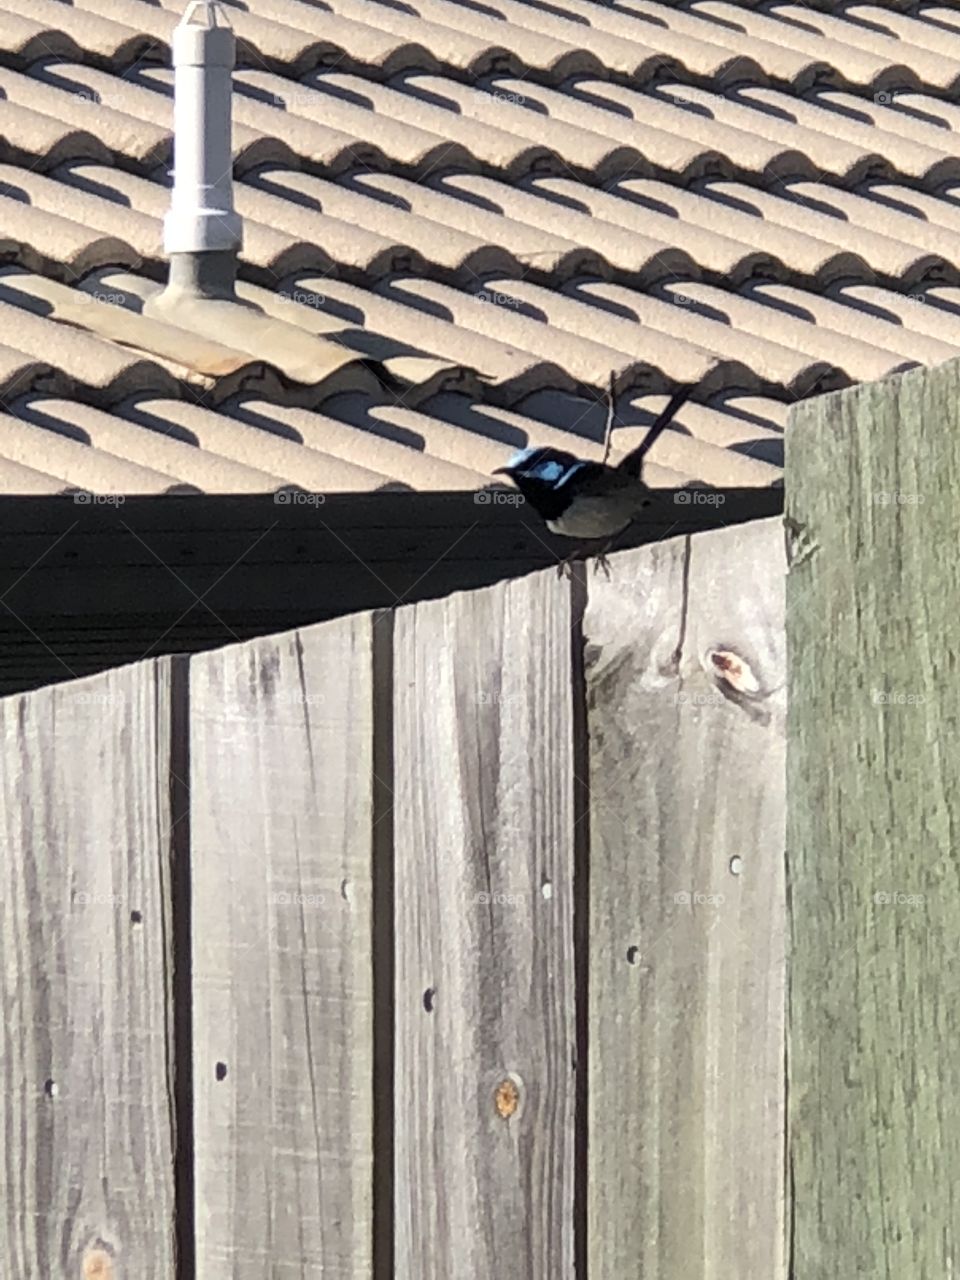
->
left=584, top=521, right=786, bottom=1280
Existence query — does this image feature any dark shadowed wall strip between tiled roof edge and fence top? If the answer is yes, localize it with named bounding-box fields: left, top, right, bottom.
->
left=0, top=489, right=783, bottom=694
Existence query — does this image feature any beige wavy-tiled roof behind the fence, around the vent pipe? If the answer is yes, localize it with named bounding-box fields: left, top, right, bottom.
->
left=0, top=0, right=960, bottom=493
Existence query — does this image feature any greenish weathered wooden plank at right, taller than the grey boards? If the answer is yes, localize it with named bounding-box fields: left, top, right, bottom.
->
left=787, top=361, right=960, bottom=1280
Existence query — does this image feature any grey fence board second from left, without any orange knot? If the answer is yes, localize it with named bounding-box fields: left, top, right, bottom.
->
left=191, top=614, right=372, bottom=1280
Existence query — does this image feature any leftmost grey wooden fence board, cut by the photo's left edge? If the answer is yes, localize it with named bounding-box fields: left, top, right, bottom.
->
left=0, top=660, right=174, bottom=1280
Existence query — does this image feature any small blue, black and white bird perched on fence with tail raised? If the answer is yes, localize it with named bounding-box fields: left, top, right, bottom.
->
left=492, top=383, right=695, bottom=576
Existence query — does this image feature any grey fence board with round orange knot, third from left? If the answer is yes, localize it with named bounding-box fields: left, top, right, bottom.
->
left=394, top=573, right=576, bottom=1280
